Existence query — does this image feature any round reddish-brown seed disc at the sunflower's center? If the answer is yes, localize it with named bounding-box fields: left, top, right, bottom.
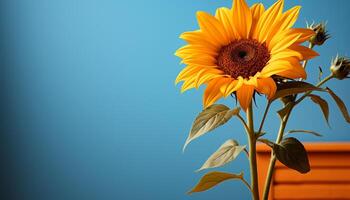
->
left=217, top=39, right=270, bottom=78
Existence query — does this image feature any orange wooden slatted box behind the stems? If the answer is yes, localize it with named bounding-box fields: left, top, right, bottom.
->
left=257, top=143, right=350, bottom=200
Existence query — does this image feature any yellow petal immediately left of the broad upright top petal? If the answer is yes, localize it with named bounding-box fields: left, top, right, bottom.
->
left=215, top=7, right=239, bottom=41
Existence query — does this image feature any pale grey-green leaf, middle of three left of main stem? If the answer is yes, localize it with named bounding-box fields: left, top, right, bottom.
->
left=197, top=139, right=246, bottom=171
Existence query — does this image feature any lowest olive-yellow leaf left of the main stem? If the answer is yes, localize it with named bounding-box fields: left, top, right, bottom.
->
left=188, top=172, right=243, bottom=194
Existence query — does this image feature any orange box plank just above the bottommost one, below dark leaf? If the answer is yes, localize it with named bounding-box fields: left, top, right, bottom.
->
left=274, top=168, right=350, bottom=184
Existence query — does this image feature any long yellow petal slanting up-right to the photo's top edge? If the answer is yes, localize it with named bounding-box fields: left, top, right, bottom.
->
left=253, top=0, right=284, bottom=43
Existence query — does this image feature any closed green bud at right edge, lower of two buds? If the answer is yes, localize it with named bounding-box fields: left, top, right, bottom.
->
left=330, top=56, right=350, bottom=80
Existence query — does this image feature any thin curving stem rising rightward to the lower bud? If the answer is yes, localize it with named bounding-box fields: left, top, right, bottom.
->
left=263, top=74, right=334, bottom=200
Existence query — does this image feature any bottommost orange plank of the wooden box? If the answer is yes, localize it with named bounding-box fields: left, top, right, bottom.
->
left=274, top=184, right=350, bottom=200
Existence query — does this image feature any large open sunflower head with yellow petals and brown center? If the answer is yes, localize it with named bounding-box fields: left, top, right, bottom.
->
left=175, top=0, right=318, bottom=110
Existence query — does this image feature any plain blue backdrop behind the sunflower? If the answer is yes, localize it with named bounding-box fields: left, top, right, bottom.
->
left=0, top=0, right=350, bottom=200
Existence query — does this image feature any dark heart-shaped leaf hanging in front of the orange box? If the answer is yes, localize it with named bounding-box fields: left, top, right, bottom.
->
left=273, top=137, right=310, bottom=174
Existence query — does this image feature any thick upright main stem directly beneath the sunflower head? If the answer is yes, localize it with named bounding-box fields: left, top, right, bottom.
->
left=247, top=103, right=259, bottom=200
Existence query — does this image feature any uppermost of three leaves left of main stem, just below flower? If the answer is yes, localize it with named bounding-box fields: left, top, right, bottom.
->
left=183, top=104, right=240, bottom=150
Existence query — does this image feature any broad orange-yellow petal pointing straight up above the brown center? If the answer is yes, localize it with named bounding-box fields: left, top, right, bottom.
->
left=232, top=0, right=252, bottom=38
